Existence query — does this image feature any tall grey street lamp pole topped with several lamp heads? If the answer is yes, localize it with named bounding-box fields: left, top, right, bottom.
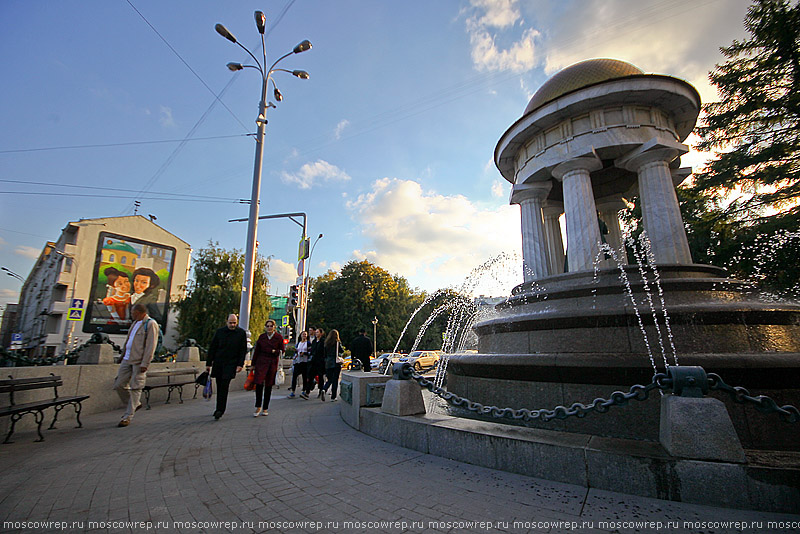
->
left=214, top=11, right=311, bottom=340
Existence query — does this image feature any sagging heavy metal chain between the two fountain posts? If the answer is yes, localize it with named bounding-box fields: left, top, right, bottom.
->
left=406, top=366, right=672, bottom=421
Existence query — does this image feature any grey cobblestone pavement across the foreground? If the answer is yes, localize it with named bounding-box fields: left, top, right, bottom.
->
left=0, top=389, right=800, bottom=534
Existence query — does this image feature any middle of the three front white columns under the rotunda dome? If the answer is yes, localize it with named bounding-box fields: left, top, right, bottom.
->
left=552, top=157, right=603, bottom=273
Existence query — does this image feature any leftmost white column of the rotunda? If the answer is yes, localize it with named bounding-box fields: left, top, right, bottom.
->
left=511, top=181, right=553, bottom=282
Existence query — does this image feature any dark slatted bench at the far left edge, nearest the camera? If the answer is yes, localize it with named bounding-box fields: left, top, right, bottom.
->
left=0, top=373, right=89, bottom=443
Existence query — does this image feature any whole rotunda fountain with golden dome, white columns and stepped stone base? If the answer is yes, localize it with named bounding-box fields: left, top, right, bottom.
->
left=447, top=59, right=800, bottom=451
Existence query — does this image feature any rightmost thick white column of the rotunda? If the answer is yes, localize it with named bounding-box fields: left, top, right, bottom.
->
left=618, top=145, right=692, bottom=264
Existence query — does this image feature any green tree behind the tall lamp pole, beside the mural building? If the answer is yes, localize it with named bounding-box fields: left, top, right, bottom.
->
left=173, top=241, right=271, bottom=347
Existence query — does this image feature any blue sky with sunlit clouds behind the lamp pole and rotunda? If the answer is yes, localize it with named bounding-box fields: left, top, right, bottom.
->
left=0, top=0, right=749, bottom=312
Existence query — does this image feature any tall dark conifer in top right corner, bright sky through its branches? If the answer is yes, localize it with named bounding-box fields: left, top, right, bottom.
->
left=693, top=0, right=800, bottom=230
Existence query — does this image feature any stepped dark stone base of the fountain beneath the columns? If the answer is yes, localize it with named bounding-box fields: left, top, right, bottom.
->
left=456, top=265, right=800, bottom=451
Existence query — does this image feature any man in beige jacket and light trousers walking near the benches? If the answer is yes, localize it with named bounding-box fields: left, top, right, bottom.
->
left=114, top=303, right=159, bottom=426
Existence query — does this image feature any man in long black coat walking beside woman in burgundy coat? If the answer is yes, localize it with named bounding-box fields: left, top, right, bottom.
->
left=206, top=313, right=247, bottom=419
